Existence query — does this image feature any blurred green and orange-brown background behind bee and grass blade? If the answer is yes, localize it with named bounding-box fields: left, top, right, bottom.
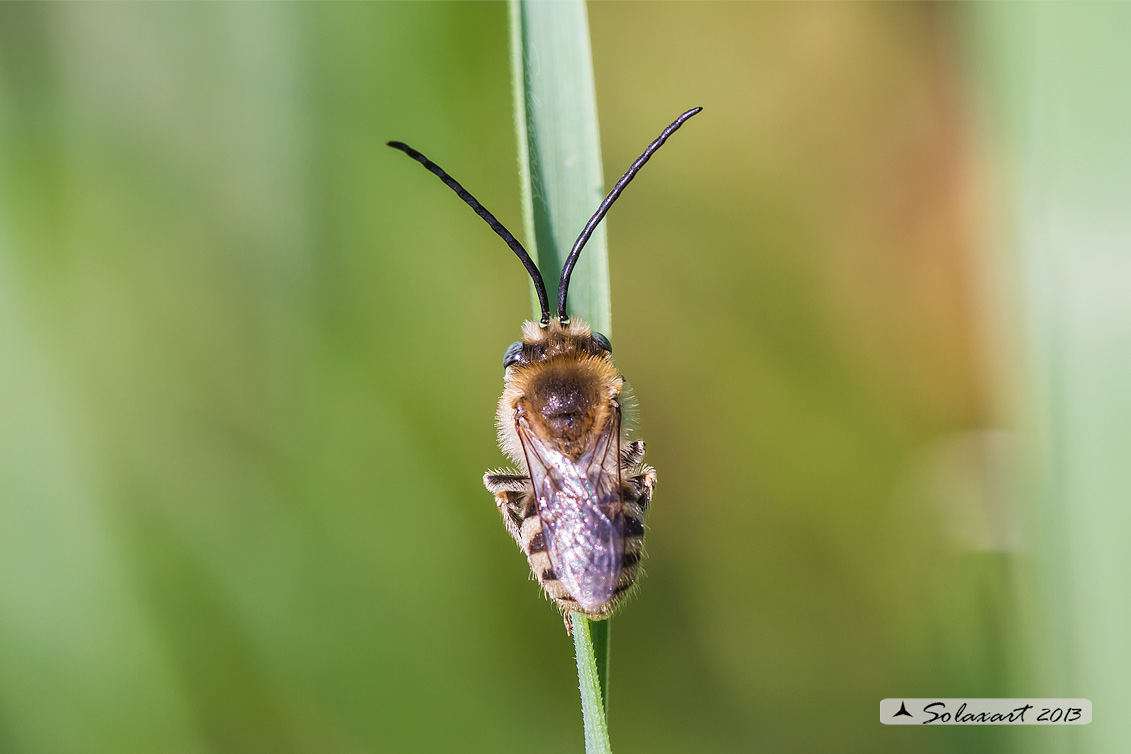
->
left=0, top=2, right=1131, bottom=754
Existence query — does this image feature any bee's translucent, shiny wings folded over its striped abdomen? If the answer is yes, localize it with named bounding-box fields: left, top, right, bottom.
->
left=515, top=406, right=624, bottom=610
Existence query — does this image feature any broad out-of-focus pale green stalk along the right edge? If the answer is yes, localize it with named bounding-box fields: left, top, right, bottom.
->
left=969, top=3, right=1131, bottom=754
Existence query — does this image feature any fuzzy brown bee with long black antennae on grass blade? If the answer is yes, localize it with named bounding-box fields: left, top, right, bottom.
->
left=389, top=107, right=702, bottom=631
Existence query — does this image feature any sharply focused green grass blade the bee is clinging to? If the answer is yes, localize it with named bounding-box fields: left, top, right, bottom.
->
left=509, top=0, right=612, bottom=753
